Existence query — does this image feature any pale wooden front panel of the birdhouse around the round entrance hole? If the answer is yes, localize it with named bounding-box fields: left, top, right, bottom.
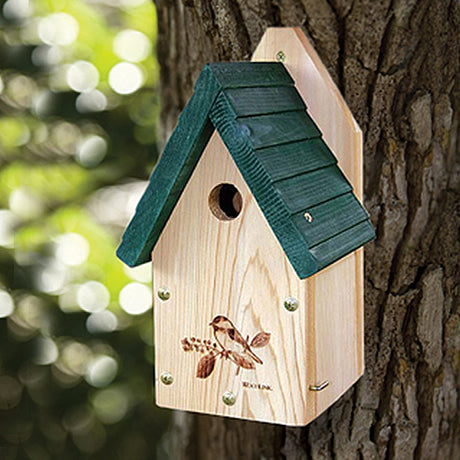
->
left=152, top=133, right=315, bottom=425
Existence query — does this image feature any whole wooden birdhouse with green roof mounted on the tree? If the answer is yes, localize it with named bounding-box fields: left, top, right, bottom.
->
left=118, top=29, right=374, bottom=425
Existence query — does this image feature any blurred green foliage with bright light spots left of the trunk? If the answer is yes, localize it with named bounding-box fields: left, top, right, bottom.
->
left=0, top=0, right=168, bottom=459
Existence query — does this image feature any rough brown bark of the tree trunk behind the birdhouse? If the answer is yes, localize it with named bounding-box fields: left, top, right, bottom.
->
left=156, top=0, right=460, bottom=460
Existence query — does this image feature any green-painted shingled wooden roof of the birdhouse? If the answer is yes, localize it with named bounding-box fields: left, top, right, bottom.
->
left=117, top=62, right=374, bottom=279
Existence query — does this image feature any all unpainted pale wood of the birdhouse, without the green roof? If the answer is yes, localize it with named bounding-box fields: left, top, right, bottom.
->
left=152, top=29, right=363, bottom=425
